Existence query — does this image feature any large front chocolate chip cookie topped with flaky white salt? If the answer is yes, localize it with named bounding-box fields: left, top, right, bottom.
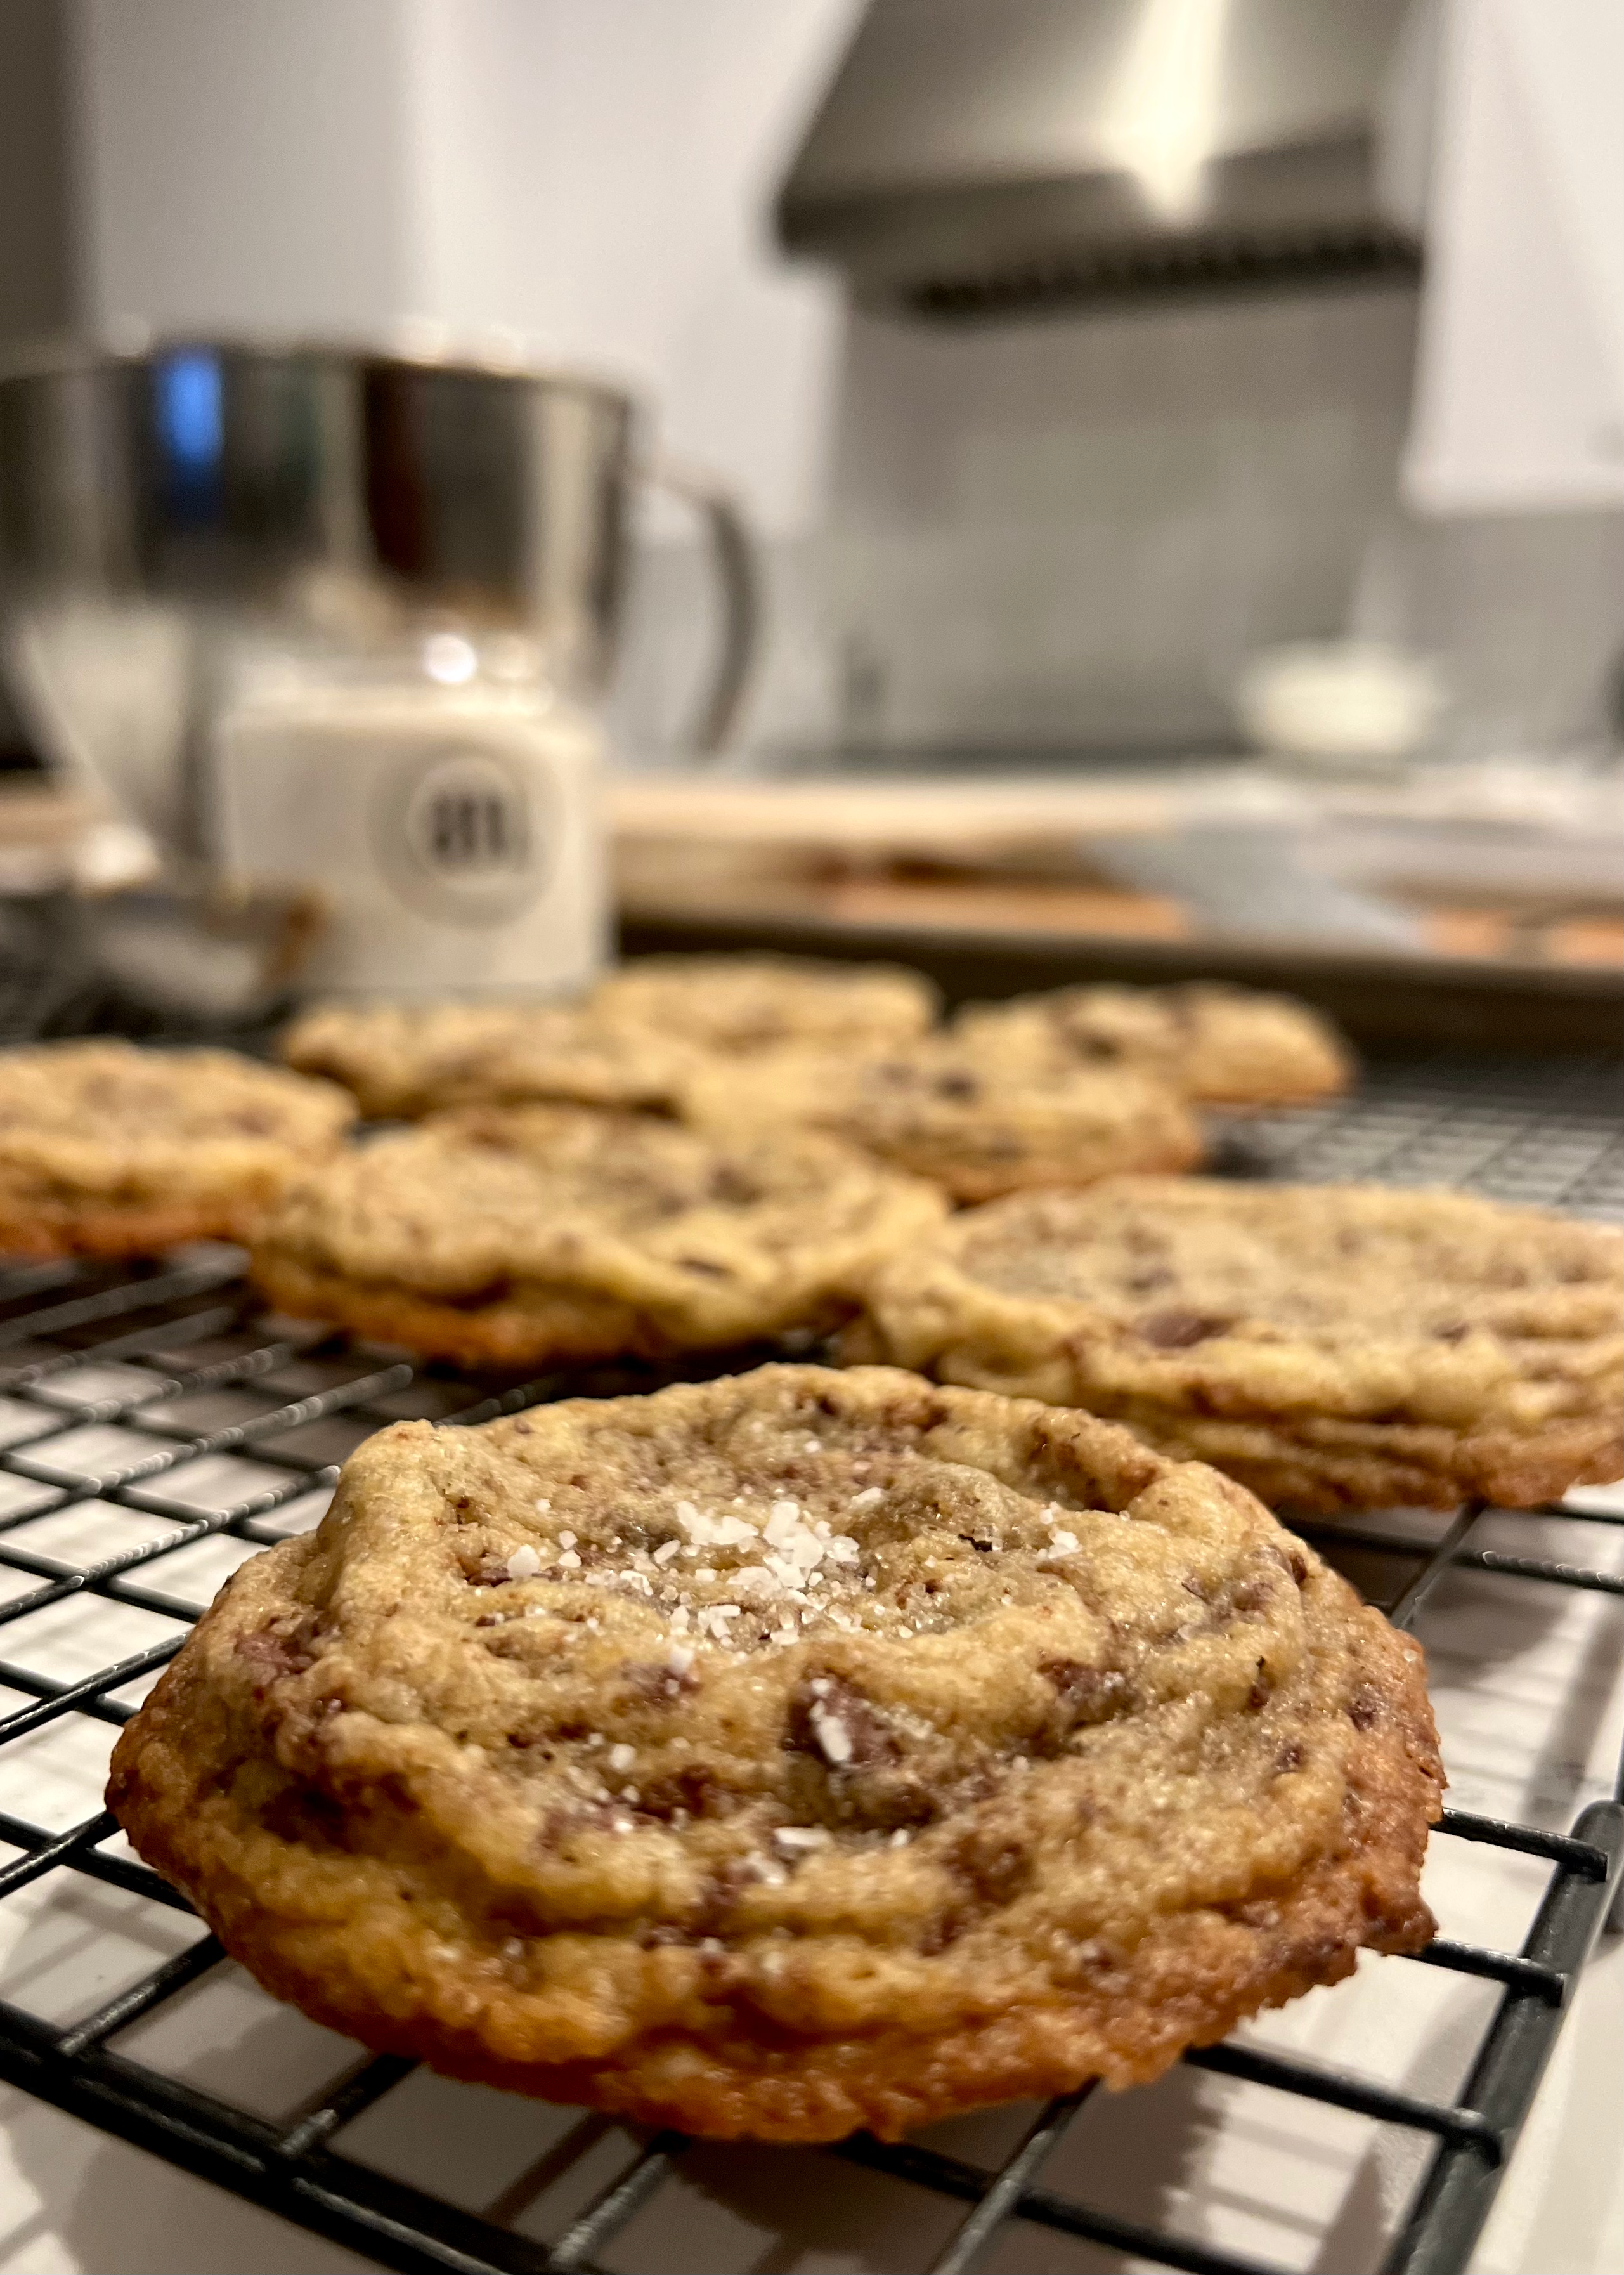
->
left=107, top=1367, right=1439, bottom=2141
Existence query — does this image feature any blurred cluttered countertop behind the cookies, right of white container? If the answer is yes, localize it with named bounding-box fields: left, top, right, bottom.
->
left=609, top=760, right=1624, bottom=969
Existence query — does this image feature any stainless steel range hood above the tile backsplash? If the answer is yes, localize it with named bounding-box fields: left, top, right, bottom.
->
left=778, top=0, right=1435, bottom=318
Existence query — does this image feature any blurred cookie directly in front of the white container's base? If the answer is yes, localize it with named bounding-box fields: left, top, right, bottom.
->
left=282, top=1001, right=696, bottom=1121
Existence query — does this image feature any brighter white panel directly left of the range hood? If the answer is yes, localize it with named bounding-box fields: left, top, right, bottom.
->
left=402, top=0, right=857, bottom=532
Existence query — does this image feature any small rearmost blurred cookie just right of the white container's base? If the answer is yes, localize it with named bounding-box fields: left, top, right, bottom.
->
left=587, top=956, right=937, bottom=1053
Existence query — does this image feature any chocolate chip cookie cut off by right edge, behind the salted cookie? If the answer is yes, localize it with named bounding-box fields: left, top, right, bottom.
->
left=848, top=1176, right=1624, bottom=1513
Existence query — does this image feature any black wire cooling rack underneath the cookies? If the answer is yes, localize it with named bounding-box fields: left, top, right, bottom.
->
left=0, top=1060, right=1624, bottom=2275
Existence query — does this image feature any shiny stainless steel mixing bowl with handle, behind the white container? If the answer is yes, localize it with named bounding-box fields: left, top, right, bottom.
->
left=0, top=341, right=755, bottom=857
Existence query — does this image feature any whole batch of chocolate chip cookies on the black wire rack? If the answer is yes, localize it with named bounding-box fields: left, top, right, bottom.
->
left=0, top=958, right=1624, bottom=2141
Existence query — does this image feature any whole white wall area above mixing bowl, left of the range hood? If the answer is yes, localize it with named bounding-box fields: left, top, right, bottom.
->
left=75, top=0, right=857, bottom=532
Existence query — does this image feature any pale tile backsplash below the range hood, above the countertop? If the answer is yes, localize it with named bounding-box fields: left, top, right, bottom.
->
left=616, top=287, right=1624, bottom=753
